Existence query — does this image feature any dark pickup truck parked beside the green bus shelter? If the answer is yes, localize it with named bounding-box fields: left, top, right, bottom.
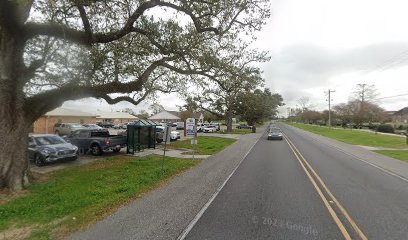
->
left=67, top=129, right=127, bottom=156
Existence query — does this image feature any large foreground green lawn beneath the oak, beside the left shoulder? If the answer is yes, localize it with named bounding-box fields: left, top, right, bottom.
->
left=0, top=155, right=199, bottom=239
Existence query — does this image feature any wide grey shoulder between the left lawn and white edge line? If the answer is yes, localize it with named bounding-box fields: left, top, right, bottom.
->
left=70, top=127, right=265, bottom=240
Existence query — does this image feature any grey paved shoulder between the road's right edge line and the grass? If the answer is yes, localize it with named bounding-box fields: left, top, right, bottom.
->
left=285, top=124, right=408, bottom=182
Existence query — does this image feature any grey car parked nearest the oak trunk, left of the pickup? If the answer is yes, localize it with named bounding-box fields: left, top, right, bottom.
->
left=28, top=134, right=78, bottom=166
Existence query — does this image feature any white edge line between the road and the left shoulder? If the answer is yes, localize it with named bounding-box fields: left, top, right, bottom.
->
left=177, top=133, right=264, bottom=240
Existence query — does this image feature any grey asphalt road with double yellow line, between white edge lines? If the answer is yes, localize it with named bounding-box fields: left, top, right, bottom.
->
left=186, top=125, right=408, bottom=239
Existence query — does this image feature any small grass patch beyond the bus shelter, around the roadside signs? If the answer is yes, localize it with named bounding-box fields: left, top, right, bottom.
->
left=167, top=136, right=236, bottom=155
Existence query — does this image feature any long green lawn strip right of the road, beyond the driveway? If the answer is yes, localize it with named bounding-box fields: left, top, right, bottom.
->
left=286, top=122, right=408, bottom=149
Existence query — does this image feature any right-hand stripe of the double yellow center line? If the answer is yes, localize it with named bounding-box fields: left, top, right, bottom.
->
left=284, top=134, right=368, bottom=240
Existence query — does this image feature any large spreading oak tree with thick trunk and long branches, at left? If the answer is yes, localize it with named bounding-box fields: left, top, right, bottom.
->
left=0, top=0, right=269, bottom=191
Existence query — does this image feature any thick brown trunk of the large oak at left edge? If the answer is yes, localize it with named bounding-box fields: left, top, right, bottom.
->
left=0, top=14, right=33, bottom=191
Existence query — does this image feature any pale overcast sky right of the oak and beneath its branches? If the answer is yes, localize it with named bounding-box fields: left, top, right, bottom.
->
left=64, top=0, right=408, bottom=116
